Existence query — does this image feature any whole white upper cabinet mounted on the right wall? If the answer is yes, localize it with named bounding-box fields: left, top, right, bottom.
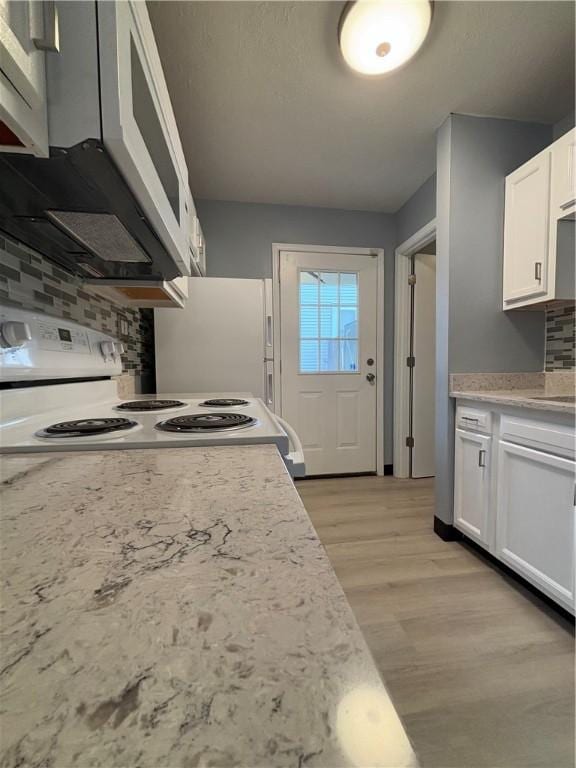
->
left=503, top=129, right=576, bottom=309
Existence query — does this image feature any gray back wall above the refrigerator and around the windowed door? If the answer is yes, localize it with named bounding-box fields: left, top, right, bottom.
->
left=196, top=200, right=396, bottom=464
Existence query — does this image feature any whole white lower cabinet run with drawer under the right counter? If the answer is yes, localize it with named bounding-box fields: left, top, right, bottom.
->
left=454, top=401, right=576, bottom=613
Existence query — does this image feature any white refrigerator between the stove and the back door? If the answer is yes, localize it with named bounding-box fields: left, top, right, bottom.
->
left=154, top=277, right=275, bottom=411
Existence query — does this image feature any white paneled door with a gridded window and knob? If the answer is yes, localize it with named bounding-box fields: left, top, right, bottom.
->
left=280, top=251, right=382, bottom=475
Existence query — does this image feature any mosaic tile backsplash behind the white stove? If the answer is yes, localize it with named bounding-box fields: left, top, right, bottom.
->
left=0, top=237, right=154, bottom=392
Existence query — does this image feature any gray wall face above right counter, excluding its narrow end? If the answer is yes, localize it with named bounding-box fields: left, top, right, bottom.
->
left=448, top=115, right=552, bottom=373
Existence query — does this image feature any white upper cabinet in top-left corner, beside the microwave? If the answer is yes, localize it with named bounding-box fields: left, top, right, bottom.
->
left=0, top=0, right=49, bottom=157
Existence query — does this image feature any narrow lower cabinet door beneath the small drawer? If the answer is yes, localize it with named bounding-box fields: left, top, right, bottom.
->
left=454, top=429, right=492, bottom=546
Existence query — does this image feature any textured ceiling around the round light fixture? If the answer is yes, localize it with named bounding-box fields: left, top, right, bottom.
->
left=148, top=0, right=574, bottom=212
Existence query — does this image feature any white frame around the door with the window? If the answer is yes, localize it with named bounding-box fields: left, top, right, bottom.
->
left=272, top=243, right=385, bottom=475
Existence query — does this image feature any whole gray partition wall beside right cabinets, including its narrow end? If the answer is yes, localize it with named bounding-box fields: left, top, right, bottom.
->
left=436, top=115, right=552, bottom=522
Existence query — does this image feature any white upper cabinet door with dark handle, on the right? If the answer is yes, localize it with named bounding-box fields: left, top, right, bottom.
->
left=504, top=150, right=551, bottom=309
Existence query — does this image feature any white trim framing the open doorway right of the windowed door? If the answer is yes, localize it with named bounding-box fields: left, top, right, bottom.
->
left=393, top=218, right=436, bottom=478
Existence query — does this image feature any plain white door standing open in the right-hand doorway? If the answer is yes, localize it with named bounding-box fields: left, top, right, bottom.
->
left=412, top=253, right=436, bottom=477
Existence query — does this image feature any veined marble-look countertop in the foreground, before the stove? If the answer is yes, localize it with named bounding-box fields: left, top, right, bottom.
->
left=0, top=446, right=417, bottom=768
